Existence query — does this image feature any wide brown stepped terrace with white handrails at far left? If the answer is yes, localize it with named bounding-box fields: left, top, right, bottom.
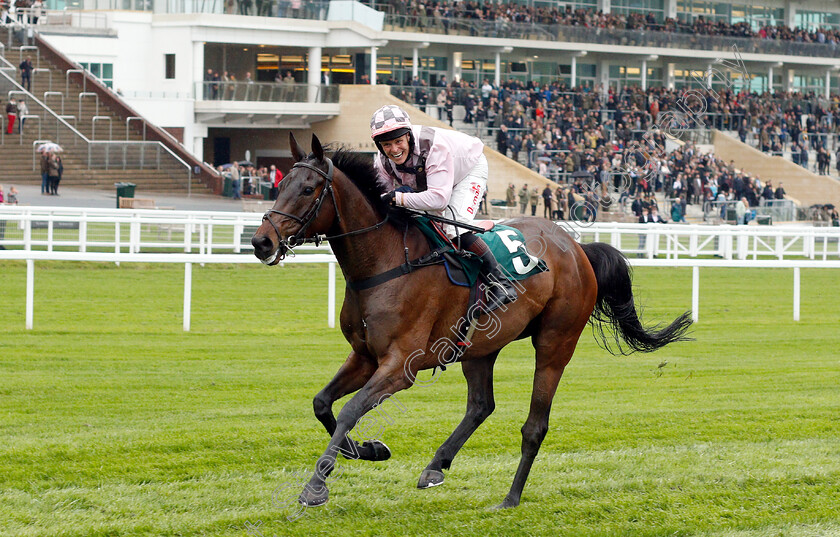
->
left=0, top=28, right=211, bottom=193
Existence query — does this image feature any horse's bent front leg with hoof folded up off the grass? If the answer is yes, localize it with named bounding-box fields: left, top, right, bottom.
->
left=312, top=351, right=391, bottom=461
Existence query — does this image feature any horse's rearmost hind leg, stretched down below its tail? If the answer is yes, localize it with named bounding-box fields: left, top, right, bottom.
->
left=498, top=338, right=583, bottom=509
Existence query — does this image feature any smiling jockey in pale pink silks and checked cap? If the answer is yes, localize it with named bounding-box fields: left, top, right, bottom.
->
left=370, top=104, right=517, bottom=307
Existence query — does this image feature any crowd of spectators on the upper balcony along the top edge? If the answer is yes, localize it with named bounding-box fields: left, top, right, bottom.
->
left=373, top=0, right=840, bottom=45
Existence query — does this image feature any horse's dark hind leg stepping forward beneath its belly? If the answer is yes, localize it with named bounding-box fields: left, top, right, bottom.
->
left=417, top=351, right=499, bottom=489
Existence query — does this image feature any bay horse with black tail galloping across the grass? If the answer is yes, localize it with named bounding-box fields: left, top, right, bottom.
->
left=251, top=133, right=691, bottom=508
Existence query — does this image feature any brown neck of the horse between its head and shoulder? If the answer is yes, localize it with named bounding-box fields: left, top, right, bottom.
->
left=330, top=178, right=416, bottom=281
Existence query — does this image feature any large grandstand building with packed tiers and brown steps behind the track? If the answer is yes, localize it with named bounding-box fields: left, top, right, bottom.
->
left=0, top=0, right=840, bottom=219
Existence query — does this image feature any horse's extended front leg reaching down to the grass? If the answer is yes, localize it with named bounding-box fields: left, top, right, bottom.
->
left=300, top=359, right=411, bottom=507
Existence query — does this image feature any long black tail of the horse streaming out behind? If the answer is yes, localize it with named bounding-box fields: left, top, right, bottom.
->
left=581, top=242, right=691, bottom=354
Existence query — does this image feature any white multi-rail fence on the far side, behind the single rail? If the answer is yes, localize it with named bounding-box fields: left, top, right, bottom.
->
left=0, top=206, right=840, bottom=260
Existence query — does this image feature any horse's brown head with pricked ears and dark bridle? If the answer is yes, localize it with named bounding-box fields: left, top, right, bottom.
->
left=251, top=133, right=335, bottom=265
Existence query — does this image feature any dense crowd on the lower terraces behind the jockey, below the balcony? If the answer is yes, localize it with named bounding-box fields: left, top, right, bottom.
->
left=394, top=77, right=840, bottom=185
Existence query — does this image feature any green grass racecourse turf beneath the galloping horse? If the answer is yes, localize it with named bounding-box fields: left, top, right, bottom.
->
left=0, top=262, right=840, bottom=537
